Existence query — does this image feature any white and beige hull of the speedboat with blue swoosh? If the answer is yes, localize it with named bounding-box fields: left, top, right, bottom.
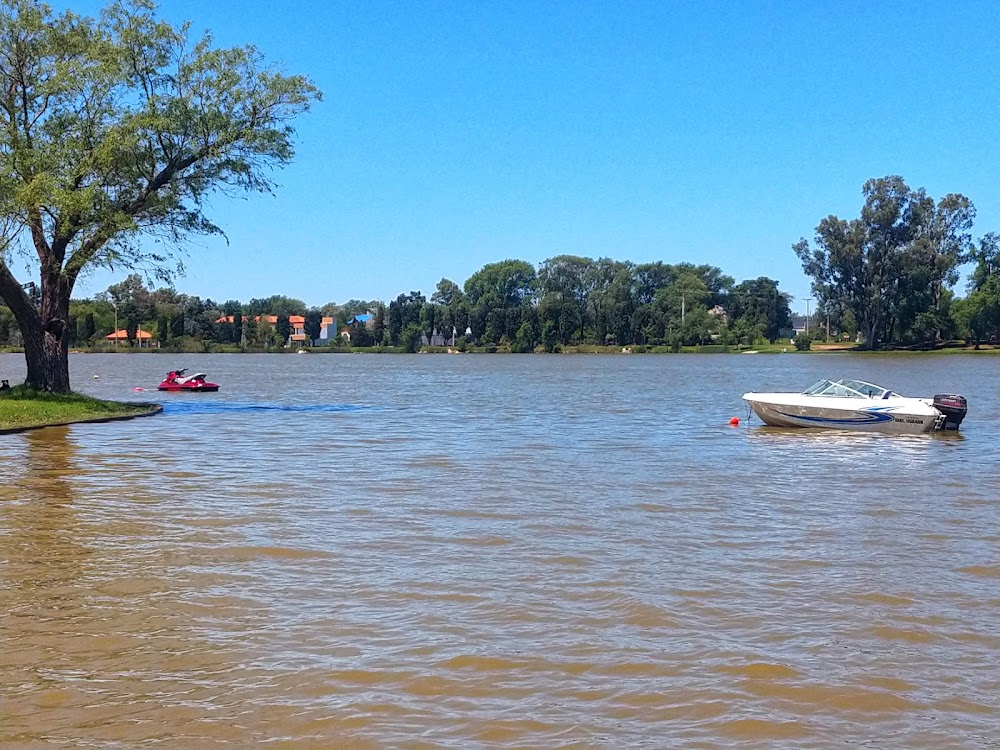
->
left=743, top=393, right=943, bottom=435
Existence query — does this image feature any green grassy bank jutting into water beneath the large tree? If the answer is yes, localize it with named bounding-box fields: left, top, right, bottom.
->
left=0, top=386, right=160, bottom=433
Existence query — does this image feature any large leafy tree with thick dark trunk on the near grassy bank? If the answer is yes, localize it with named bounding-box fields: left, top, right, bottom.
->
left=0, top=0, right=320, bottom=392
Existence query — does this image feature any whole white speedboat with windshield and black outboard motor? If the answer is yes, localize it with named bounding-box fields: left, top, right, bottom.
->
left=743, top=378, right=968, bottom=434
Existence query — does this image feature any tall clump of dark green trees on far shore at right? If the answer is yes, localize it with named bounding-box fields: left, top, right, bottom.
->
left=794, top=176, right=1000, bottom=348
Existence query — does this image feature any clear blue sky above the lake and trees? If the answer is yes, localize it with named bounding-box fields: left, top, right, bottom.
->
left=64, top=0, right=1000, bottom=311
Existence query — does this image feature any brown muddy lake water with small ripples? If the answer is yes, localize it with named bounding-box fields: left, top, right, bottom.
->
left=0, top=354, right=1000, bottom=749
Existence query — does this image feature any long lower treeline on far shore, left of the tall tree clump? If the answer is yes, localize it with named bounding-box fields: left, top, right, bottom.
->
left=0, top=255, right=791, bottom=351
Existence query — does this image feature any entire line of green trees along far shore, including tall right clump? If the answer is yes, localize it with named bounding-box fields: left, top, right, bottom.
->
left=0, top=177, right=1000, bottom=352
